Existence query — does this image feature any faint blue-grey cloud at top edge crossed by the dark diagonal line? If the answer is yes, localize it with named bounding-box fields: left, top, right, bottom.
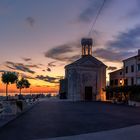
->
left=78, top=0, right=113, bottom=22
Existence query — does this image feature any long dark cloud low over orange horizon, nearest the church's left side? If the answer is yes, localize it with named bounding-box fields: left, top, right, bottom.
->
left=36, top=75, right=60, bottom=83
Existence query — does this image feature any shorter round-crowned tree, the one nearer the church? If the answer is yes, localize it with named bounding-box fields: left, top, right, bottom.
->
left=16, top=78, right=31, bottom=95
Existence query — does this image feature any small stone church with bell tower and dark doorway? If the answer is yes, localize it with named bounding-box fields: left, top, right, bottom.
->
left=59, top=38, right=107, bottom=101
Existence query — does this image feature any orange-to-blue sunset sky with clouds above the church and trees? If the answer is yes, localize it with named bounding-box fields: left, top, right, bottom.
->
left=0, top=0, right=140, bottom=93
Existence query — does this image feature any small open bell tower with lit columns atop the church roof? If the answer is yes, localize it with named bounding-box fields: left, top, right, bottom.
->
left=81, top=38, right=93, bottom=57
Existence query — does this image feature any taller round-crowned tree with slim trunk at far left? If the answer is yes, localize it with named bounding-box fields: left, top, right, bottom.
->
left=1, top=71, right=18, bottom=100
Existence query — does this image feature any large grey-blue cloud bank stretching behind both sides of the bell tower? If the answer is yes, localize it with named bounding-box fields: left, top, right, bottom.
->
left=45, top=25, right=140, bottom=63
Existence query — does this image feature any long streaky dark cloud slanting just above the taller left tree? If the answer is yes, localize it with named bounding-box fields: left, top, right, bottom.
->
left=5, top=61, right=35, bottom=74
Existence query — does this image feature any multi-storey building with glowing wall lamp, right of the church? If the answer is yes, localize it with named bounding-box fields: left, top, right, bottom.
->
left=110, top=50, right=140, bottom=86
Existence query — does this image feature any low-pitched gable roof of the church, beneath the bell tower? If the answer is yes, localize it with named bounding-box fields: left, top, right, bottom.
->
left=65, top=55, right=106, bottom=68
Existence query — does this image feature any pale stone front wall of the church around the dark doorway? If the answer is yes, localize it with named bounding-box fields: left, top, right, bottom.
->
left=66, top=67, right=106, bottom=101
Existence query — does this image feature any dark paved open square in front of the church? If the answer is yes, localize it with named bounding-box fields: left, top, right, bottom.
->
left=0, top=101, right=140, bottom=140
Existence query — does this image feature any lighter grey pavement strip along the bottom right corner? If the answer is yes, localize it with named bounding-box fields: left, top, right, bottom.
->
left=37, top=125, right=140, bottom=140
